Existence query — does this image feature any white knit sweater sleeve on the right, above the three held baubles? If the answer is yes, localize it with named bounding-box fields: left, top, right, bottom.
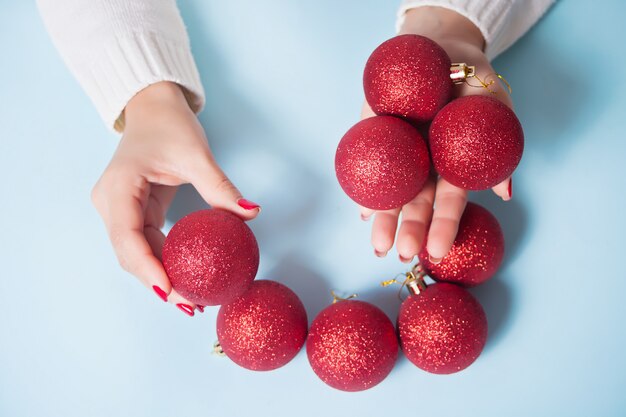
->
left=396, top=0, right=554, bottom=60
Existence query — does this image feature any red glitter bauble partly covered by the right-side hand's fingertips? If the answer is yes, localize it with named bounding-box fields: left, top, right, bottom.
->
left=419, top=203, right=504, bottom=287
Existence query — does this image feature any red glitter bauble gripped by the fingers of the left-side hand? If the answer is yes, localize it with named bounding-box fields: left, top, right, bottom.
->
left=162, top=209, right=259, bottom=306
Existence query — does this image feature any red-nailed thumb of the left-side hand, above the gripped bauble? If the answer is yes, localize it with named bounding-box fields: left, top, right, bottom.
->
left=189, top=157, right=261, bottom=220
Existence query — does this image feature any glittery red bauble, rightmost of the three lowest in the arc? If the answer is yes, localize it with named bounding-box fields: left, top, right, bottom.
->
left=398, top=283, right=487, bottom=374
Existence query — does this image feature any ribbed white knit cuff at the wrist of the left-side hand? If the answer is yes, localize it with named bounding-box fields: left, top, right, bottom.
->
left=77, top=33, right=205, bottom=132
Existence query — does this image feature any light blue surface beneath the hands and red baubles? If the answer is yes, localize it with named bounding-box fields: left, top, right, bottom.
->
left=0, top=0, right=626, bottom=417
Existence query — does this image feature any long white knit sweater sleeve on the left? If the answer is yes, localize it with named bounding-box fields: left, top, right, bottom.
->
left=37, top=0, right=204, bottom=131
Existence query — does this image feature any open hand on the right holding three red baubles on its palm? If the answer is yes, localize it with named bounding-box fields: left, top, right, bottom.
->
left=360, top=6, right=513, bottom=263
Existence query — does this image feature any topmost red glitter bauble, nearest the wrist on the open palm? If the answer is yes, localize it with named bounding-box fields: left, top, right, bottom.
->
left=363, top=35, right=453, bottom=123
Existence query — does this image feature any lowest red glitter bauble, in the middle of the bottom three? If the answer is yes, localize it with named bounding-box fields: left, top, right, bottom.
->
left=306, top=300, right=398, bottom=391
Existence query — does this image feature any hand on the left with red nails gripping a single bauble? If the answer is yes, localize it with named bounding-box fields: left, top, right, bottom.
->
left=92, top=82, right=260, bottom=316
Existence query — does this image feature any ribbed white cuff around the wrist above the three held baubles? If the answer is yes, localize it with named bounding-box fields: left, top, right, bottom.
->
left=396, top=0, right=511, bottom=57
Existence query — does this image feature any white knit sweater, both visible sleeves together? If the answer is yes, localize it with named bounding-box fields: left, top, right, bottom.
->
left=37, top=0, right=553, bottom=131
